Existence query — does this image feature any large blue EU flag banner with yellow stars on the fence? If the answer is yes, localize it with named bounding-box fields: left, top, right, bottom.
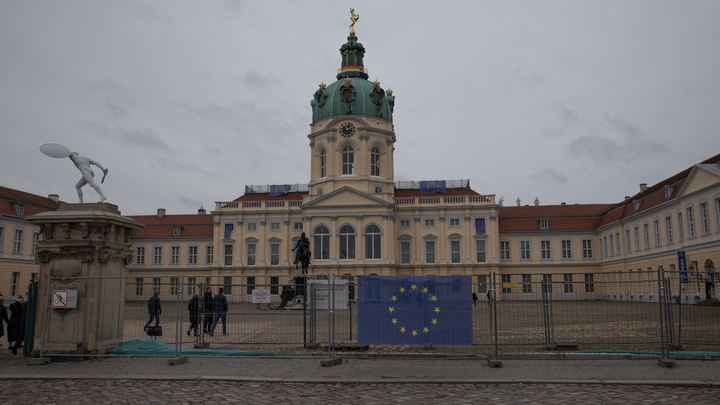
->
left=357, top=276, right=473, bottom=345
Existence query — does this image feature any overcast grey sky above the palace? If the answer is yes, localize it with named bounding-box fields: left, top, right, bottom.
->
left=0, top=0, right=720, bottom=215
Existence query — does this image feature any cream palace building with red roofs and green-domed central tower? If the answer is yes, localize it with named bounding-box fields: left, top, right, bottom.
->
left=0, top=22, right=720, bottom=302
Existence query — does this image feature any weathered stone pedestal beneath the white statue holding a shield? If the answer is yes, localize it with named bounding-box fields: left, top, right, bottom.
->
left=28, top=203, right=143, bottom=356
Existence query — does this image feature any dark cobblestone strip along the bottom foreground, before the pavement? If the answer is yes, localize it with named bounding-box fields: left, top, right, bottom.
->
left=0, top=379, right=720, bottom=405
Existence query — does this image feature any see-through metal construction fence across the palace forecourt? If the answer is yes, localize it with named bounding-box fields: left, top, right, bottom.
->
left=35, top=269, right=720, bottom=359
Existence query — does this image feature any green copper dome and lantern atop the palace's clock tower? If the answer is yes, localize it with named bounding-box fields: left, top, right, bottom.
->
left=310, top=35, right=395, bottom=122
